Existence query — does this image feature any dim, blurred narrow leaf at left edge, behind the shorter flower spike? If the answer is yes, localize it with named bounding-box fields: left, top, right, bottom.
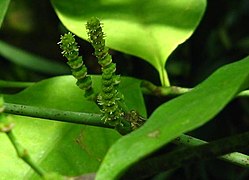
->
left=0, top=41, right=69, bottom=75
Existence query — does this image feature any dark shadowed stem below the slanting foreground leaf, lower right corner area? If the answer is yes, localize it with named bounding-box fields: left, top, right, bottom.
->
left=124, top=132, right=249, bottom=179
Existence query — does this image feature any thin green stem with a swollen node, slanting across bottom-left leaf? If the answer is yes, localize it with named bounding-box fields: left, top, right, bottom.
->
left=6, top=130, right=45, bottom=177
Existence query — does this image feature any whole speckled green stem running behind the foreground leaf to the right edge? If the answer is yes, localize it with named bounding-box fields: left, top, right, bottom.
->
left=4, top=103, right=249, bottom=167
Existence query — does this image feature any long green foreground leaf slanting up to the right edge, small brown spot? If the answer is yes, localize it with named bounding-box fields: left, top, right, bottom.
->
left=96, top=56, right=249, bottom=180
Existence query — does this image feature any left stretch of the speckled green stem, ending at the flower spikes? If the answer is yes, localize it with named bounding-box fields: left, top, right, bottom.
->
left=4, top=103, right=112, bottom=128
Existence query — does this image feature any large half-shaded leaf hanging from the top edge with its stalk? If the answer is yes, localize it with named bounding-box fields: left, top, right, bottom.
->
left=51, top=0, right=206, bottom=85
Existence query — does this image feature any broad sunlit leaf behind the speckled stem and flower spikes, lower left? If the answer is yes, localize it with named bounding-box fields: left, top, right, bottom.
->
left=0, top=76, right=146, bottom=179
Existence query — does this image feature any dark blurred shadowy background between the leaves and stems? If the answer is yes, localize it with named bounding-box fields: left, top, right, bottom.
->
left=0, top=0, right=249, bottom=179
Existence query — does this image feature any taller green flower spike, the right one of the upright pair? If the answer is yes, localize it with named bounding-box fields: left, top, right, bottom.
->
left=86, top=17, right=124, bottom=125
